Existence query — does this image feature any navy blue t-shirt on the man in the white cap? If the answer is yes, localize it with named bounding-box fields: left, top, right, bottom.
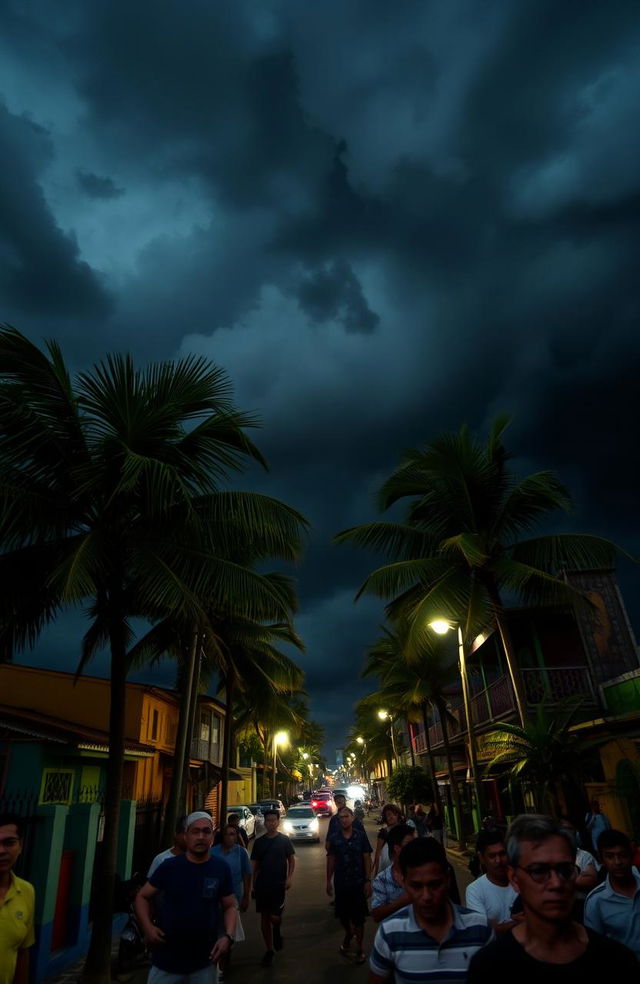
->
left=149, top=854, right=233, bottom=974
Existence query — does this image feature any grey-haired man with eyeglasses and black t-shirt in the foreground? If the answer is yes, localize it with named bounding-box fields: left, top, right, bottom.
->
left=467, top=814, right=638, bottom=984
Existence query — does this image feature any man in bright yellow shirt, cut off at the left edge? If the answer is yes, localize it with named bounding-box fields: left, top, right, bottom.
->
left=0, top=813, right=35, bottom=984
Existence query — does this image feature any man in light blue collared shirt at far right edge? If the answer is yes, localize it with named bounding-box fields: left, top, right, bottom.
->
left=584, top=830, right=640, bottom=969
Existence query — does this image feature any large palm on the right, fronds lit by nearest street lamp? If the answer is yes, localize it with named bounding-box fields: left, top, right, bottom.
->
left=336, top=416, right=618, bottom=725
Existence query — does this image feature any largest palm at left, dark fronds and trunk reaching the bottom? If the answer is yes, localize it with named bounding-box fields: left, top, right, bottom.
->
left=0, top=327, right=305, bottom=984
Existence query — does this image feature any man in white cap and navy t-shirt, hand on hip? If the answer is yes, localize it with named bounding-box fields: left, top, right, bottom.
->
left=135, top=811, right=237, bottom=984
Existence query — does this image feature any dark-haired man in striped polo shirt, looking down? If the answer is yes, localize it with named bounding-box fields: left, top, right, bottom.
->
left=369, top=837, right=493, bottom=984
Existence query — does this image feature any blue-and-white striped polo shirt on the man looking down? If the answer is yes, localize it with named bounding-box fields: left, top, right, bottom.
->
left=369, top=903, right=494, bottom=984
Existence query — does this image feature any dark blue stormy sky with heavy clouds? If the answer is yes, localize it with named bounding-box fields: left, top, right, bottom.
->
left=0, top=0, right=640, bottom=750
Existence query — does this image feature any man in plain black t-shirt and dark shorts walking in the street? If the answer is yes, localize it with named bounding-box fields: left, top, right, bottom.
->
left=251, top=810, right=296, bottom=967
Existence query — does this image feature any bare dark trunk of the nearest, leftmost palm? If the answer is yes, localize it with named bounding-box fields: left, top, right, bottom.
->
left=82, top=620, right=128, bottom=984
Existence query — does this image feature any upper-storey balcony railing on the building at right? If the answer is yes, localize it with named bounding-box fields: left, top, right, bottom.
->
left=414, top=666, right=596, bottom=755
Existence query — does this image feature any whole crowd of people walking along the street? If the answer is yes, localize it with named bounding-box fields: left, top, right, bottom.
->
left=0, top=795, right=640, bottom=984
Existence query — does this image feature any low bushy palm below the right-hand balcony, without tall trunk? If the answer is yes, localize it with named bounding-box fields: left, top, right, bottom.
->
left=483, top=700, right=598, bottom=816
